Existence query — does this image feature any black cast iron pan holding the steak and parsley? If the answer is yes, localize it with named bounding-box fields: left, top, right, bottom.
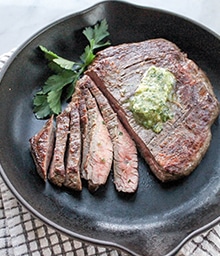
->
left=0, top=1, right=220, bottom=256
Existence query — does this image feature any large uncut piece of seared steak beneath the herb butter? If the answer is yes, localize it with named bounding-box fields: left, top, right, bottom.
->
left=86, top=38, right=219, bottom=181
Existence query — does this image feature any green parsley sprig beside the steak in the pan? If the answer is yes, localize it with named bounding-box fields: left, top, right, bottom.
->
left=33, top=19, right=110, bottom=119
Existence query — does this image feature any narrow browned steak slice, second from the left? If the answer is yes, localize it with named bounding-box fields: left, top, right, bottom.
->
left=48, top=105, right=71, bottom=186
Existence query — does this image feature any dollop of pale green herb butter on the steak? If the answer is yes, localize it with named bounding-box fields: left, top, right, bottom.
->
left=130, top=66, right=176, bottom=133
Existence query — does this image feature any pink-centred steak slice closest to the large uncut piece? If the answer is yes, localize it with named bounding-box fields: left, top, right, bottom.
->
left=86, top=76, right=138, bottom=193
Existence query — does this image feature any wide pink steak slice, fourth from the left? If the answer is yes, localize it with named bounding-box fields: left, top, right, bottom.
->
left=78, top=77, right=113, bottom=191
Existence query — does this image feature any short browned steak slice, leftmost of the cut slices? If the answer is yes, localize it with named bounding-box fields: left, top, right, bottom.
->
left=29, top=116, right=55, bottom=181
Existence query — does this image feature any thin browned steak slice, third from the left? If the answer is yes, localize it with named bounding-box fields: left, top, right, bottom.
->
left=64, top=89, right=82, bottom=191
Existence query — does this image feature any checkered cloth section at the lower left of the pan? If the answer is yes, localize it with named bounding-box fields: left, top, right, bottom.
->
left=0, top=175, right=126, bottom=256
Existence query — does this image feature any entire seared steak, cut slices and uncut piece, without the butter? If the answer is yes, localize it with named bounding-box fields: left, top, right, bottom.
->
left=30, top=39, right=220, bottom=189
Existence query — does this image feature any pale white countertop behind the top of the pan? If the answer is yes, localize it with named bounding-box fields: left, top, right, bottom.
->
left=0, top=0, right=220, bottom=55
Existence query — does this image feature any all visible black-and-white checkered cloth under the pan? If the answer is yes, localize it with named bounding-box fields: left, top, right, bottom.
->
left=0, top=50, right=220, bottom=256
